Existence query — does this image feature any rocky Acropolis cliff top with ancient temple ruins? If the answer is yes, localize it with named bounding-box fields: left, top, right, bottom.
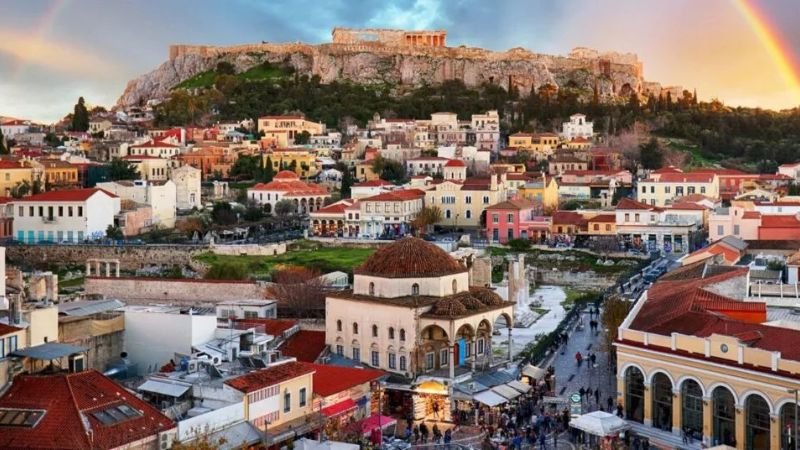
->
left=117, top=28, right=662, bottom=107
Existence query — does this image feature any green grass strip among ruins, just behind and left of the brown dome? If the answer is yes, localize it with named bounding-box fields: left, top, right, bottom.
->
left=195, top=247, right=375, bottom=278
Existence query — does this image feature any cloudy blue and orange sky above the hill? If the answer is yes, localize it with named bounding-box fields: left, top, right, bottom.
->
left=0, top=0, right=800, bottom=123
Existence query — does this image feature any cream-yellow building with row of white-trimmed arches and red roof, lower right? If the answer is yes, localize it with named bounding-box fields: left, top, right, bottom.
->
left=614, top=262, right=800, bottom=449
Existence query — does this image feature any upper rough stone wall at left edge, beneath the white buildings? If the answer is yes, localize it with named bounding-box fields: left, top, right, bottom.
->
left=6, top=245, right=208, bottom=270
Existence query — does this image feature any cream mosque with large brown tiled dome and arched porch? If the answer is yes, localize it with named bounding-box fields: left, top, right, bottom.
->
left=325, top=237, right=514, bottom=418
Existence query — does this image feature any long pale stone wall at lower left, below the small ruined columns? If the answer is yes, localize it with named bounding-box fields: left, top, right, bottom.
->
left=84, top=277, right=264, bottom=306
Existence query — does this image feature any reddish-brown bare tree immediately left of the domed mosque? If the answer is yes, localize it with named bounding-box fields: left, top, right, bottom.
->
left=267, top=266, right=326, bottom=318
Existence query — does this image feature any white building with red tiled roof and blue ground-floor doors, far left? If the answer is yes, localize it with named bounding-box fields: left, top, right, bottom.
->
left=12, top=188, right=120, bottom=243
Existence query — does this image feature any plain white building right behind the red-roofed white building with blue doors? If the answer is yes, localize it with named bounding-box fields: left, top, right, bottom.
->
left=97, top=180, right=177, bottom=228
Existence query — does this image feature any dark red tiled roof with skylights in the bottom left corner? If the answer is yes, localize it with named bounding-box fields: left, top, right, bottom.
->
left=0, top=370, right=175, bottom=449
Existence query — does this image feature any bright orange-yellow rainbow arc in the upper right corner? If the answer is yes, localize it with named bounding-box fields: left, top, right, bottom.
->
left=732, top=0, right=800, bottom=103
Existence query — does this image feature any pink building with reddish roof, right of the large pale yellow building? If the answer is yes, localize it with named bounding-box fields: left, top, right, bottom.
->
left=486, top=199, right=550, bottom=244
